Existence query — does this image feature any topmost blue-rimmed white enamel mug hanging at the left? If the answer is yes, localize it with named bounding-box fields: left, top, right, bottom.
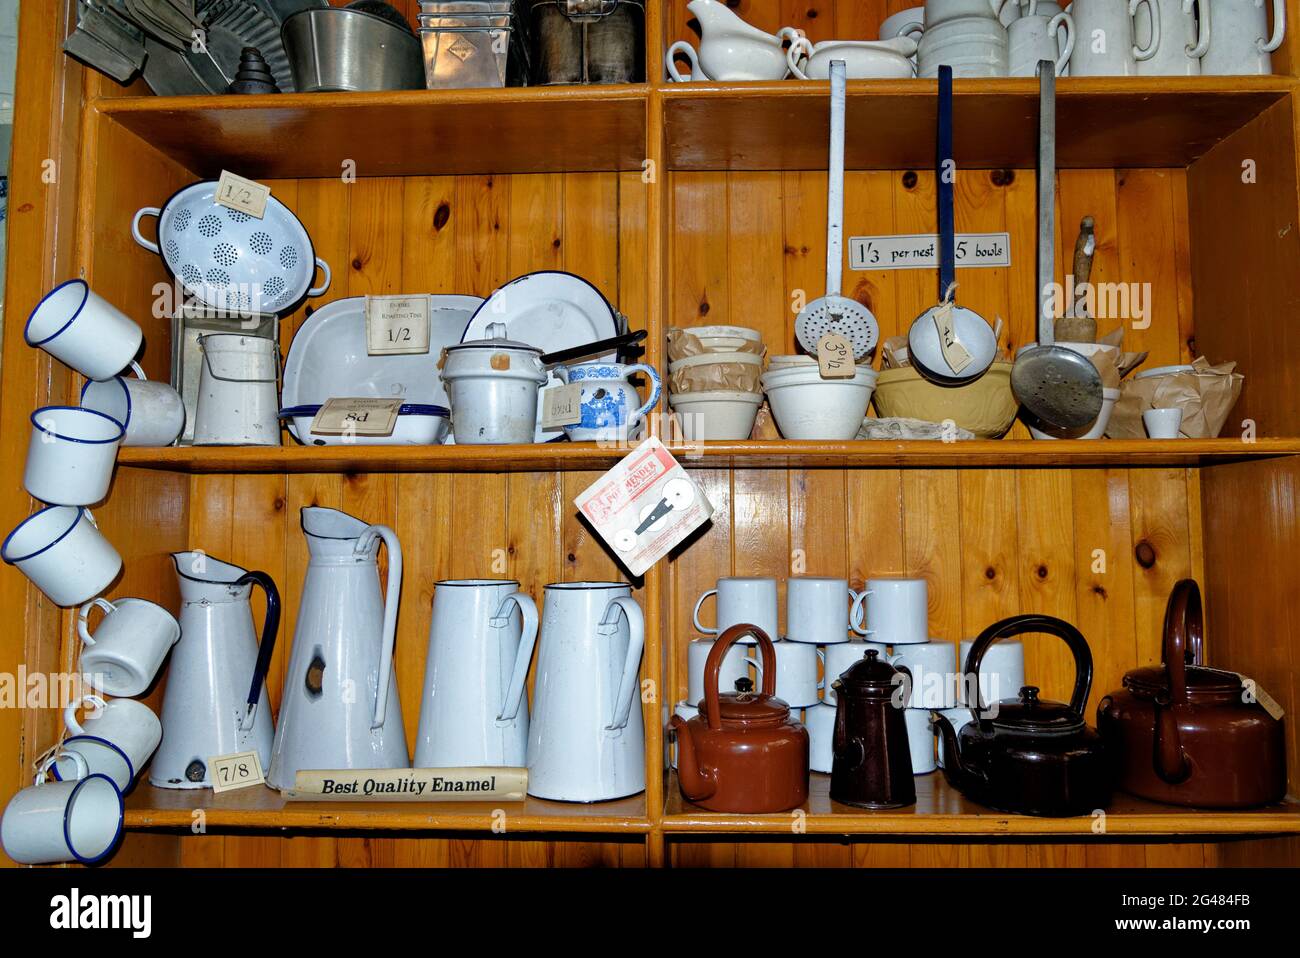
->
left=23, top=279, right=144, bottom=380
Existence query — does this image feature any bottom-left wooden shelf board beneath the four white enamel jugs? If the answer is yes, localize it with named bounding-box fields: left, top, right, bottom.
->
left=126, top=783, right=650, bottom=833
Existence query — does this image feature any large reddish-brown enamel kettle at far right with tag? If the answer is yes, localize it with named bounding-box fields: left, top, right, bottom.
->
left=1097, top=578, right=1287, bottom=809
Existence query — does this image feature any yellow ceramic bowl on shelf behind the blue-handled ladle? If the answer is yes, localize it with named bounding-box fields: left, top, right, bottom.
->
left=872, top=363, right=1021, bottom=439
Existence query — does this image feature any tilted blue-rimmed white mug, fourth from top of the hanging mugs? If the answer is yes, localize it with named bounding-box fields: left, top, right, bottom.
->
left=0, top=506, right=122, bottom=608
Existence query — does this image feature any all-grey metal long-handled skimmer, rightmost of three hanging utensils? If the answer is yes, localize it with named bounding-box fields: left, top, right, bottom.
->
left=1011, top=60, right=1101, bottom=429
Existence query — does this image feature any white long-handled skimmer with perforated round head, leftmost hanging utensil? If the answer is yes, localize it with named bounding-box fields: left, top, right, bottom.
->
left=794, top=60, right=880, bottom=360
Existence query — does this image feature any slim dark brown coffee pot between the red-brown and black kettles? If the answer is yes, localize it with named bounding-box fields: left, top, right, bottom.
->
left=831, top=649, right=917, bottom=809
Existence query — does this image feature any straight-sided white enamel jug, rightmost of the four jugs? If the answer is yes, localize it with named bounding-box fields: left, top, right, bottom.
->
left=528, top=582, right=646, bottom=802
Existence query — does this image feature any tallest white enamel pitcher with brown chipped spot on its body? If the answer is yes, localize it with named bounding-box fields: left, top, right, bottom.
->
left=267, top=506, right=411, bottom=789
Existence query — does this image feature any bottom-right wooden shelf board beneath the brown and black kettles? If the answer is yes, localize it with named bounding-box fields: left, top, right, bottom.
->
left=663, top=772, right=1300, bottom=841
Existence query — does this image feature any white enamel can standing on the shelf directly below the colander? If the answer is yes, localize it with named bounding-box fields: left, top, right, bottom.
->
left=194, top=333, right=280, bottom=446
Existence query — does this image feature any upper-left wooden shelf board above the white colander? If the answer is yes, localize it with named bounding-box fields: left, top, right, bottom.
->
left=94, top=86, right=647, bottom=179
